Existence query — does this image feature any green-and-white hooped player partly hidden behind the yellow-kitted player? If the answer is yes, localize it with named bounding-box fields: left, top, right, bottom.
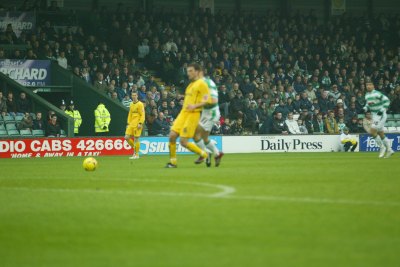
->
left=194, top=73, right=224, bottom=167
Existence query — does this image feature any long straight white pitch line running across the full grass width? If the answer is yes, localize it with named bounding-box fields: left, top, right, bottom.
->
left=0, top=187, right=400, bottom=207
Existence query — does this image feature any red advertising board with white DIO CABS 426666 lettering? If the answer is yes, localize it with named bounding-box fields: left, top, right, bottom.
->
left=0, top=137, right=132, bottom=158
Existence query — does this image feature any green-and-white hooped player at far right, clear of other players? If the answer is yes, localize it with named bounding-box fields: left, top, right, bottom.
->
left=364, top=81, right=394, bottom=158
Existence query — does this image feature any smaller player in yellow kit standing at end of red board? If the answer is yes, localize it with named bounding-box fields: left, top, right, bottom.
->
left=125, top=92, right=145, bottom=159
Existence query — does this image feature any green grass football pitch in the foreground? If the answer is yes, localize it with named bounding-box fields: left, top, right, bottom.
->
left=0, top=153, right=400, bottom=267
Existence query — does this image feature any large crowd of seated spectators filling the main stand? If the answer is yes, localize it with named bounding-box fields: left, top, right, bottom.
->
left=0, top=2, right=400, bottom=135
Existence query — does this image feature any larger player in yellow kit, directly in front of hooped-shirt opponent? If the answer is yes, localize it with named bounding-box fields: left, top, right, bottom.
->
left=165, top=63, right=210, bottom=168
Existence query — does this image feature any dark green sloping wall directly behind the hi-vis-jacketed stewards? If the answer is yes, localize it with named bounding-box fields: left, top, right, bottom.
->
left=52, top=63, right=128, bottom=136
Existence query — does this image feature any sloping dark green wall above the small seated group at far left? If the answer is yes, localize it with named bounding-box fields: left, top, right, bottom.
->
left=0, top=72, right=74, bottom=137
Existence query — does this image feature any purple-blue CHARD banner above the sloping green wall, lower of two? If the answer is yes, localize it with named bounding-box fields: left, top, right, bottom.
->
left=0, top=59, right=50, bottom=86
